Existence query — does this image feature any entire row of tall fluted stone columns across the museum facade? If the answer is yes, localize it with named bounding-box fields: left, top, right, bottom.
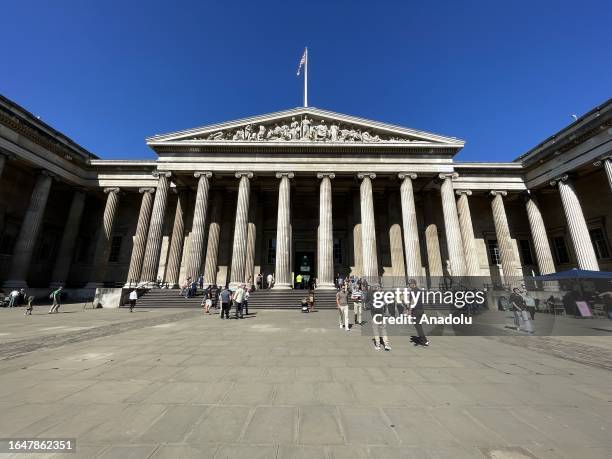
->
left=0, top=154, right=612, bottom=289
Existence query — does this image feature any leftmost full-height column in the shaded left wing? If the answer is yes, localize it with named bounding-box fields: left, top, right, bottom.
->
left=4, top=171, right=53, bottom=288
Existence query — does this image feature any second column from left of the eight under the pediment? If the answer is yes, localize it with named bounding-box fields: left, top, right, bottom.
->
left=186, top=172, right=212, bottom=279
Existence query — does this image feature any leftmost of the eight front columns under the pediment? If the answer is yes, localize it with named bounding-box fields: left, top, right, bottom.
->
left=140, top=172, right=170, bottom=282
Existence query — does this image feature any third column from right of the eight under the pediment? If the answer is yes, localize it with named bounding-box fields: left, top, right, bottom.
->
left=357, top=172, right=380, bottom=285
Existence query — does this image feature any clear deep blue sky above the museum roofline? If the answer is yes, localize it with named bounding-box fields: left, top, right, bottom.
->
left=0, top=0, right=612, bottom=161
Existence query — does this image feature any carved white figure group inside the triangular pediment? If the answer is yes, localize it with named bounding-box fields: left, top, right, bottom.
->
left=193, top=115, right=412, bottom=143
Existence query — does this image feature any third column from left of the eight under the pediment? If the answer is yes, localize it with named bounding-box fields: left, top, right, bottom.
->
left=230, top=172, right=253, bottom=286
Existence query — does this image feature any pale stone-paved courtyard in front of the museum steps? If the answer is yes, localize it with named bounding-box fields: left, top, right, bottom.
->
left=0, top=305, right=612, bottom=459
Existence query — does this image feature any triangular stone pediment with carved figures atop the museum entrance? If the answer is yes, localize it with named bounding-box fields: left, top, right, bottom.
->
left=147, top=107, right=464, bottom=148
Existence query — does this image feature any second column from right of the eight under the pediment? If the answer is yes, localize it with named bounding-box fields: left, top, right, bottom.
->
left=398, top=173, right=420, bottom=278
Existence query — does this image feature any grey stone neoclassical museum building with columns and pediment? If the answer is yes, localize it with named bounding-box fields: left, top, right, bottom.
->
left=0, top=93, right=612, bottom=304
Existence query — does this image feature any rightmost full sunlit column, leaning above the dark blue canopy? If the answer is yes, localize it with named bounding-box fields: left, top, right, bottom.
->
left=550, top=175, right=599, bottom=271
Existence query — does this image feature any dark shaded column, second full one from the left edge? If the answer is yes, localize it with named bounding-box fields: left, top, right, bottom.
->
left=49, top=190, right=86, bottom=288
